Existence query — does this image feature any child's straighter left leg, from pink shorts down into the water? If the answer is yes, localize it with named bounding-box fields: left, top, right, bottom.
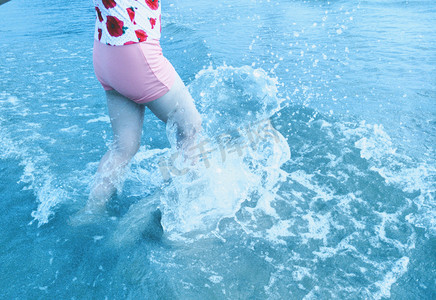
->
left=72, top=90, right=145, bottom=222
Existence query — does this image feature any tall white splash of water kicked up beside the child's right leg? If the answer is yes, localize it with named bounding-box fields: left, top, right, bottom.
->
left=138, top=66, right=290, bottom=238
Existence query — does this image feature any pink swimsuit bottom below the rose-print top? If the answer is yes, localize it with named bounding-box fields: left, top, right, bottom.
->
left=93, top=40, right=177, bottom=104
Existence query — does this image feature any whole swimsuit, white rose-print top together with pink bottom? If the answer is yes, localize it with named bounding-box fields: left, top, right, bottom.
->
left=93, top=0, right=177, bottom=103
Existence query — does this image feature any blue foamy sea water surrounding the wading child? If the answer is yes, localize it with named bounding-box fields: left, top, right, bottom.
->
left=0, top=0, right=436, bottom=299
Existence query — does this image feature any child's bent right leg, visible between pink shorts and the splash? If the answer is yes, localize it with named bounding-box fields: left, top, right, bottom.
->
left=147, top=75, right=201, bottom=151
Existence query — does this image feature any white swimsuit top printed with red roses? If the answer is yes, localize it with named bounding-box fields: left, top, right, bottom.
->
left=94, top=0, right=162, bottom=46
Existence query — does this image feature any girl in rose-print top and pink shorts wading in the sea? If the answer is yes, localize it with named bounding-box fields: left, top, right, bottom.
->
left=70, top=0, right=201, bottom=225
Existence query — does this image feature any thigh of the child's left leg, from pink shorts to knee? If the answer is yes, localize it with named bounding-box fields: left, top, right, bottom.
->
left=106, top=90, right=145, bottom=148
